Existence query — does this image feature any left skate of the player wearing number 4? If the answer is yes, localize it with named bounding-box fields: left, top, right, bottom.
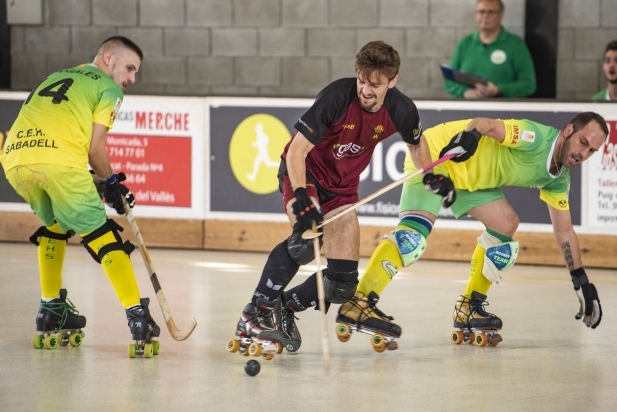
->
left=32, top=289, right=86, bottom=349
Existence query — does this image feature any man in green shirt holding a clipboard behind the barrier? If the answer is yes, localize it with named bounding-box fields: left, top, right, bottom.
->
left=446, top=0, right=536, bottom=99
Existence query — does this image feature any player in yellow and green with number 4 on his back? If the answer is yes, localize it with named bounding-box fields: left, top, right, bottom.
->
left=0, top=37, right=160, bottom=356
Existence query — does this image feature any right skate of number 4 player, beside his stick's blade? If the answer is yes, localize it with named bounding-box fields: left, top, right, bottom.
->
left=126, top=298, right=161, bottom=358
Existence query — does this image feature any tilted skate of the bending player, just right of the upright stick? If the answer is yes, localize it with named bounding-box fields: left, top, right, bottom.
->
left=336, top=292, right=401, bottom=353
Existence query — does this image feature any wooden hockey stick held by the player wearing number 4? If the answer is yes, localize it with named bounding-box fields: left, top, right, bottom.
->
left=122, top=199, right=197, bottom=341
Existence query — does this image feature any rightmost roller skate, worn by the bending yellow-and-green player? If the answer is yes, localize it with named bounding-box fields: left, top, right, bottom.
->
left=451, top=292, right=502, bottom=346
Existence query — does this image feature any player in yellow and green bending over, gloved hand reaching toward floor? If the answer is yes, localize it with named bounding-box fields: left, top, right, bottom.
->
left=339, top=112, right=608, bottom=346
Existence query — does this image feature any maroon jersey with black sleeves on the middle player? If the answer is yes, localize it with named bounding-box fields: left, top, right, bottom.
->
left=283, top=78, right=422, bottom=200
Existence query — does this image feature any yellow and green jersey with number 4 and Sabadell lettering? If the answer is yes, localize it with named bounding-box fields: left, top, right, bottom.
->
left=0, top=64, right=123, bottom=172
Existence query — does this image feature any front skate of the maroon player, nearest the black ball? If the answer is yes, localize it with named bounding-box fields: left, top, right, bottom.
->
left=227, top=298, right=289, bottom=360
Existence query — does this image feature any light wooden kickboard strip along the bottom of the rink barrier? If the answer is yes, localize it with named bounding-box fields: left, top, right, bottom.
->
left=0, top=212, right=617, bottom=269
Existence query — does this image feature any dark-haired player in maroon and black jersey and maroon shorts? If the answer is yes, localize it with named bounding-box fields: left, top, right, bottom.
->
left=230, top=41, right=436, bottom=358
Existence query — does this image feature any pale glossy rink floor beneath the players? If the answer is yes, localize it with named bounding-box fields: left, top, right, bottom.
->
left=0, top=243, right=617, bottom=412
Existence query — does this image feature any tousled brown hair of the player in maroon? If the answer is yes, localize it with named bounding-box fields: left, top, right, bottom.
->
left=356, top=40, right=401, bottom=80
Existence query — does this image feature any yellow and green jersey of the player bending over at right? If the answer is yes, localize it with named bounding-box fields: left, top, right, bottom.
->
left=406, top=119, right=570, bottom=210
